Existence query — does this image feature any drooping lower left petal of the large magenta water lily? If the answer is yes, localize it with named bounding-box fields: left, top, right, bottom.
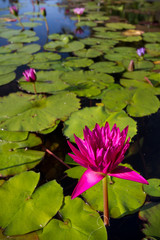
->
left=71, top=169, right=105, bottom=199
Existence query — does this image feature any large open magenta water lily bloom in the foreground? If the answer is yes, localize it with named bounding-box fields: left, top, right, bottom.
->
left=68, top=123, right=148, bottom=199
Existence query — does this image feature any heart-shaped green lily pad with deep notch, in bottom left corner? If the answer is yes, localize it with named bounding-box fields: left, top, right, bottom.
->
left=0, top=171, right=63, bottom=235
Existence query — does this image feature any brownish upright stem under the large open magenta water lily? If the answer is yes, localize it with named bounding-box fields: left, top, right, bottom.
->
left=102, top=176, right=109, bottom=226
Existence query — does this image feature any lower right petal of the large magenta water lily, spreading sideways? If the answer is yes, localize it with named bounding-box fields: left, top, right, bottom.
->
left=108, top=166, right=149, bottom=184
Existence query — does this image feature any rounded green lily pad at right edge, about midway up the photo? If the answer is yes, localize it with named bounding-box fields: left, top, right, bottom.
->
left=127, top=89, right=160, bottom=117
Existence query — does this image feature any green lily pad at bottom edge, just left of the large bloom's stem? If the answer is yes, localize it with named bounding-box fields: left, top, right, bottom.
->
left=39, top=197, right=107, bottom=240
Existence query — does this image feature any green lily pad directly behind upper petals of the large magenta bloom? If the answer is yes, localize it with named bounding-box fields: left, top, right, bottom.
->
left=63, top=106, right=137, bottom=142
